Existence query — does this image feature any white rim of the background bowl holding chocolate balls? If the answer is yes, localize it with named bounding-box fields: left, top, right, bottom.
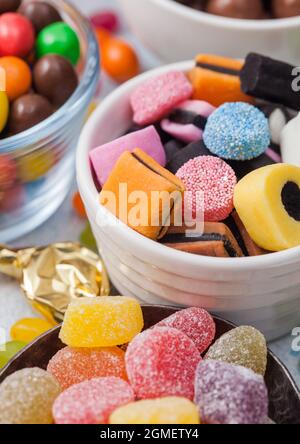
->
left=155, top=0, right=300, bottom=31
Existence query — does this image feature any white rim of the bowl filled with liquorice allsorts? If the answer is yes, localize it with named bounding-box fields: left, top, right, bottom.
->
left=76, top=61, right=300, bottom=271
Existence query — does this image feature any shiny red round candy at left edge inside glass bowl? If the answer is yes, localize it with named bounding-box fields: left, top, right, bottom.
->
left=0, top=12, right=35, bottom=57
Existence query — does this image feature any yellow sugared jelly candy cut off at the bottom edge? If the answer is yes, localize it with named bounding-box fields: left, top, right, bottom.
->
left=109, top=396, right=200, bottom=424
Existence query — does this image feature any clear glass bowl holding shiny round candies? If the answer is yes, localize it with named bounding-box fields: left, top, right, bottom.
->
left=0, top=0, right=99, bottom=243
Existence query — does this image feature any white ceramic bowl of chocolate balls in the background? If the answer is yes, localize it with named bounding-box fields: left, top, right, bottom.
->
left=119, top=0, right=300, bottom=65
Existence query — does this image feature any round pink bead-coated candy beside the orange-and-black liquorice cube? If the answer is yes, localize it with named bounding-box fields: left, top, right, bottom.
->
left=176, top=156, right=237, bottom=222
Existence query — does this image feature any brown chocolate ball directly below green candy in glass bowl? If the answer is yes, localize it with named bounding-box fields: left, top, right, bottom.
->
left=33, top=54, right=78, bottom=107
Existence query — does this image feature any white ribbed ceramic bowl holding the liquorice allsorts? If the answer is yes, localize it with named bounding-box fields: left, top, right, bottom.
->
left=76, top=62, right=300, bottom=339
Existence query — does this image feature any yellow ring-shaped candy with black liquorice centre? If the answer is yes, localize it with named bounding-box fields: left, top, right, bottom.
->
left=234, top=163, right=300, bottom=251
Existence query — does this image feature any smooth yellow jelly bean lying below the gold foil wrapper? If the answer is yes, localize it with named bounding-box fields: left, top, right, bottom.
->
left=10, top=318, right=53, bottom=342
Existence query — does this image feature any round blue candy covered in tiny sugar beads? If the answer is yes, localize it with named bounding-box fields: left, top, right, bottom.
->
left=203, top=102, right=271, bottom=160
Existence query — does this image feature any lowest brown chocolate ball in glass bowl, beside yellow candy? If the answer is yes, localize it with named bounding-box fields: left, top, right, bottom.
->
left=8, top=94, right=53, bottom=135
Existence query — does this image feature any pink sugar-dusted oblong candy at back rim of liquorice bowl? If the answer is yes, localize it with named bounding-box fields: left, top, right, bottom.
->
left=131, top=71, right=193, bottom=125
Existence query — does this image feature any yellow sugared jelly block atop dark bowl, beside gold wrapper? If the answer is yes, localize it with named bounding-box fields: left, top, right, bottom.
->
left=59, top=296, right=144, bottom=347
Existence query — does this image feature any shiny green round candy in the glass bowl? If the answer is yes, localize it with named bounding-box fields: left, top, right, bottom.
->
left=36, top=22, right=80, bottom=65
